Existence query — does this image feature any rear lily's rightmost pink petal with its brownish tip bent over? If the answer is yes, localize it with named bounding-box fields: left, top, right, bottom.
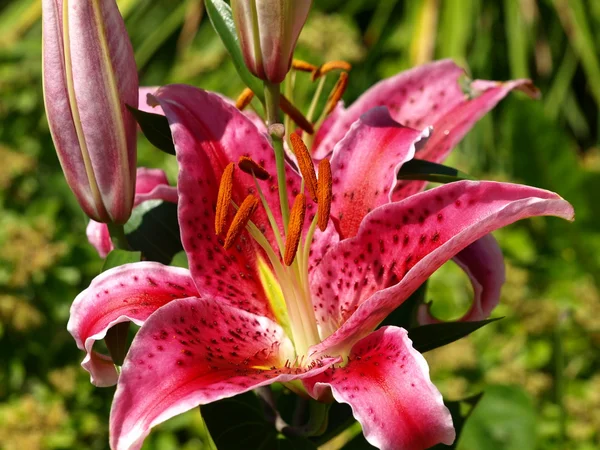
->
left=393, top=79, right=539, bottom=201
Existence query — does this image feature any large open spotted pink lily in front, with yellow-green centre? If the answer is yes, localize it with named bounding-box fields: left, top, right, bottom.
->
left=68, top=75, right=573, bottom=449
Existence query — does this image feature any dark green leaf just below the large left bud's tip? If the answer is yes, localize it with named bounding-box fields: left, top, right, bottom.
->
left=125, top=200, right=183, bottom=264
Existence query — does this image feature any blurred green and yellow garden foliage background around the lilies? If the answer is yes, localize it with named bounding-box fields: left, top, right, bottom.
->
left=0, top=0, right=600, bottom=450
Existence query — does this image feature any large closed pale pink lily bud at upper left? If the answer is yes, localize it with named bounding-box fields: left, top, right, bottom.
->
left=42, top=0, right=138, bottom=224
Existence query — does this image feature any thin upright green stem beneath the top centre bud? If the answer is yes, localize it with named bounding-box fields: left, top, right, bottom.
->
left=265, top=81, right=290, bottom=229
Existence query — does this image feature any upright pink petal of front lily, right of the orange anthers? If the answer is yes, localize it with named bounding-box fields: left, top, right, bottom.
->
left=331, top=107, right=430, bottom=239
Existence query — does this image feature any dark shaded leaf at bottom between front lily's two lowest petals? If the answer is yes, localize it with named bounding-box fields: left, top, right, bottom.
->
left=201, top=392, right=317, bottom=450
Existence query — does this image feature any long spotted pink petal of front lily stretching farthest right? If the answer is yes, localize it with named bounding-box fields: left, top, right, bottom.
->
left=310, top=181, right=574, bottom=351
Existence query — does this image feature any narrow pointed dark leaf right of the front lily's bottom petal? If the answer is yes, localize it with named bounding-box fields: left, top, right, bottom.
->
left=408, top=317, right=502, bottom=353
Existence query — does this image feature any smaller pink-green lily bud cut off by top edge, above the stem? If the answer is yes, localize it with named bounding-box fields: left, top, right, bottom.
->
left=231, top=0, right=312, bottom=83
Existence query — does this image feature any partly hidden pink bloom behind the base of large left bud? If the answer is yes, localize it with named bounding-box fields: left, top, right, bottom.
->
left=85, top=167, right=177, bottom=258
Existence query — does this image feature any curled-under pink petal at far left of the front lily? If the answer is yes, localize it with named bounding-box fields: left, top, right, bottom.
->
left=67, top=262, right=198, bottom=386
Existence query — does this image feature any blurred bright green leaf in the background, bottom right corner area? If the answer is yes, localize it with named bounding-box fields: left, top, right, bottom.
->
left=458, top=386, right=537, bottom=450
